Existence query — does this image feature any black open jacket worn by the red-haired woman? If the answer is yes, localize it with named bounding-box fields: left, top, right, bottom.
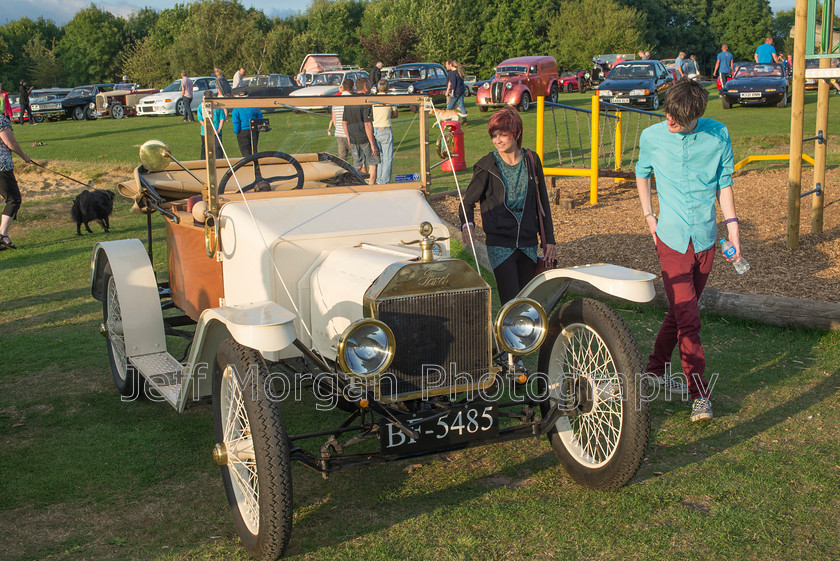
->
left=461, top=150, right=554, bottom=247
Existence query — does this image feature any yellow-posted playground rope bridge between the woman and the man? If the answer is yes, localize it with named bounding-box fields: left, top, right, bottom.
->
left=536, top=95, right=665, bottom=205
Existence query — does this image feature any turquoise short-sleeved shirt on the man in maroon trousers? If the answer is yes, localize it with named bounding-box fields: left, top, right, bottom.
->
left=636, top=119, right=735, bottom=253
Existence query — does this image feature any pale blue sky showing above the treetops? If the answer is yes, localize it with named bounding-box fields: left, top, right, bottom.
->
left=0, top=0, right=796, bottom=25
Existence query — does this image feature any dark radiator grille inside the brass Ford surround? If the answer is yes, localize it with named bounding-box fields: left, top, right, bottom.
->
left=376, top=288, right=490, bottom=397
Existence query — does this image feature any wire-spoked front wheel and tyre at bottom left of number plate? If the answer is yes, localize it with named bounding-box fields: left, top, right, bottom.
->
left=213, top=339, right=293, bottom=561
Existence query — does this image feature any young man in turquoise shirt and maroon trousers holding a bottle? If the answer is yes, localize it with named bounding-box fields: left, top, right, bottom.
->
left=636, top=80, right=741, bottom=421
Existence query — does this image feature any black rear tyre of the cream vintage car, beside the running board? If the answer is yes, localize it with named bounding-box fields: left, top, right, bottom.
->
left=102, top=265, right=146, bottom=400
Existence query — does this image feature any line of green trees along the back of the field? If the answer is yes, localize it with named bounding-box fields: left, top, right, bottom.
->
left=0, top=0, right=794, bottom=89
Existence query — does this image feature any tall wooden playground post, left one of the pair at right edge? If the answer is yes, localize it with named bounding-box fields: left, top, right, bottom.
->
left=787, top=0, right=808, bottom=249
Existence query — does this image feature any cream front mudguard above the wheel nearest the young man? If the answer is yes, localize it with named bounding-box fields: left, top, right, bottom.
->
left=519, top=263, right=656, bottom=307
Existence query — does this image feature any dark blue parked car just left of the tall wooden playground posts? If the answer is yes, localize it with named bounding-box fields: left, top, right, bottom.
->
left=720, top=62, right=790, bottom=109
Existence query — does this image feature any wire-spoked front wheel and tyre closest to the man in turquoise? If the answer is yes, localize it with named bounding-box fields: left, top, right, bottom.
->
left=539, top=298, right=650, bottom=490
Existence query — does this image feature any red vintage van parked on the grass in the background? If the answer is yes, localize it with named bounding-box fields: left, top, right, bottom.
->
left=475, top=56, right=560, bottom=111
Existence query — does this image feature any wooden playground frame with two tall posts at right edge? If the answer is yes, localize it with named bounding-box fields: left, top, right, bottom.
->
left=787, top=0, right=840, bottom=249
